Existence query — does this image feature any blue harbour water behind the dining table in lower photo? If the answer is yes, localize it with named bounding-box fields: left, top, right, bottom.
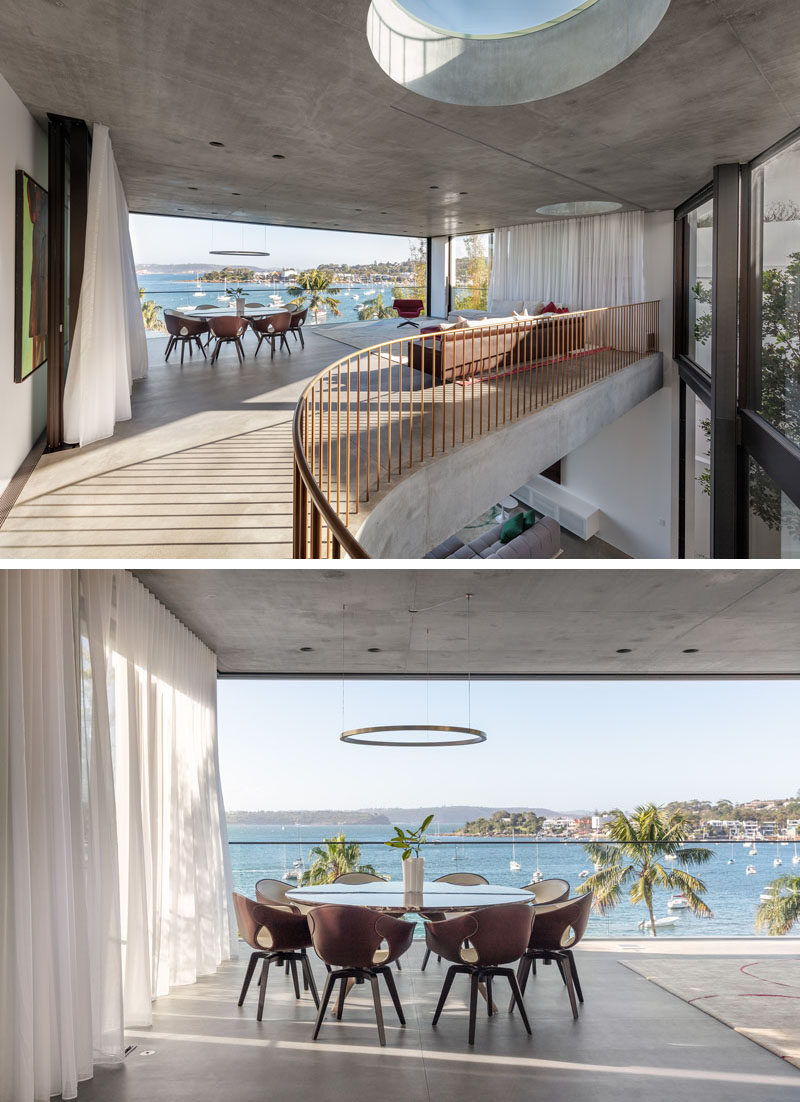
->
left=228, top=823, right=800, bottom=938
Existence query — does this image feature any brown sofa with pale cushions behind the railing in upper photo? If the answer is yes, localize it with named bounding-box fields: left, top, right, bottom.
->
left=411, top=314, right=586, bottom=382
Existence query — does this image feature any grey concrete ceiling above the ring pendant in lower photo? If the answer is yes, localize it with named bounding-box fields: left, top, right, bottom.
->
left=136, top=566, right=800, bottom=678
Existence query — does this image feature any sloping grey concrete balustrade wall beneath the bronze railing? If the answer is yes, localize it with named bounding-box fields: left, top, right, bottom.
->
left=356, top=354, right=663, bottom=559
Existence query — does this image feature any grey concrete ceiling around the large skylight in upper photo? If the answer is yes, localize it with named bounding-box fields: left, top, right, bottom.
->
left=0, top=0, right=800, bottom=236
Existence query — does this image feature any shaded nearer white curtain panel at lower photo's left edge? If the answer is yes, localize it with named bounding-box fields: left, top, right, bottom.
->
left=0, top=571, right=122, bottom=1102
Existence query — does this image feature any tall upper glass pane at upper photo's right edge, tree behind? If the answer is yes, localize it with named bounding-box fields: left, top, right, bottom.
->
left=753, top=135, right=800, bottom=444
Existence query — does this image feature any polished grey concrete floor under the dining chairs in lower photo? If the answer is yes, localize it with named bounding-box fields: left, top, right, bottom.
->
left=67, top=941, right=800, bottom=1102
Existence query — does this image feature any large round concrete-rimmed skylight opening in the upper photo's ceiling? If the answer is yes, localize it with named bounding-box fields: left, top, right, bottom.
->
left=367, top=0, right=670, bottom=107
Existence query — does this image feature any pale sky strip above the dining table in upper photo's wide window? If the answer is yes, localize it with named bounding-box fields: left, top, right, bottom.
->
left=130, top=214, right=410, bottom=269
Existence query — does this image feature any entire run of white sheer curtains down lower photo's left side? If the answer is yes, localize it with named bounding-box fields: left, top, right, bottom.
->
left=0, top=571, right=236, bottom=1102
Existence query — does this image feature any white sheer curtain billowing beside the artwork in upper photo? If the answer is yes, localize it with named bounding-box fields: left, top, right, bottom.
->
left=64, top=123, right=148, bottom=444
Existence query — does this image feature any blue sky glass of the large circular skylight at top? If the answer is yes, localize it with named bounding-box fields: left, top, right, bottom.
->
left=398, top=0, right=597, bottom=37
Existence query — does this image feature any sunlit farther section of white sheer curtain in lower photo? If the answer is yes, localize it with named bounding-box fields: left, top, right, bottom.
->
left=110, top=573, right=236, bottom=1026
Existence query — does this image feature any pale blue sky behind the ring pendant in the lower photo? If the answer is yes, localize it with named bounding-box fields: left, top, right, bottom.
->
left=218, top=680, right=800, bottom=811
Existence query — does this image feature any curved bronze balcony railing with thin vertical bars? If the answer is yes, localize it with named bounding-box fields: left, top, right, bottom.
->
left=293, top=301, right=659, bottom=559
